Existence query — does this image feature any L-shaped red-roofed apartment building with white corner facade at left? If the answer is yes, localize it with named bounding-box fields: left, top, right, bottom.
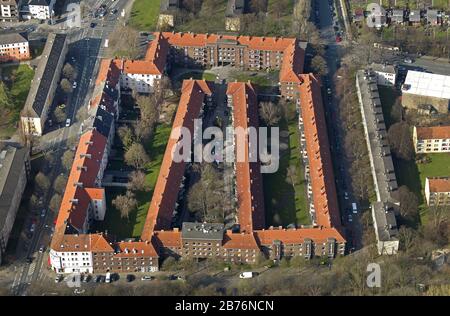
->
left=50, top=60, right=163, bottom=273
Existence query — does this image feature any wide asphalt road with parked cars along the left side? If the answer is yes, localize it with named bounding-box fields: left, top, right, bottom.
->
left=7, top=0, right=127, bottom=295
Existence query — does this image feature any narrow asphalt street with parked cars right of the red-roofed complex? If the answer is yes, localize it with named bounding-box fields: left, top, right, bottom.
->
left=316, top=1, right=362, bottom=249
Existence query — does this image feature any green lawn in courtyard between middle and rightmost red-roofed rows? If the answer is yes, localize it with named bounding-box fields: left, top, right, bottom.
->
left=263, top=107, right=311, bottom=226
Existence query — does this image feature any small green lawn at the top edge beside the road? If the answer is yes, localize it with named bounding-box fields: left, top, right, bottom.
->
left=129, top=0, right=161, bottom=31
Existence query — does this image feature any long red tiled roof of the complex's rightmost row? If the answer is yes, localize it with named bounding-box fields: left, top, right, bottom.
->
left=299, top=74, right=341, bottom=227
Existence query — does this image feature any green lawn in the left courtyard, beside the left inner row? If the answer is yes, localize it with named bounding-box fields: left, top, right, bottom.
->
left=99, top=124, right=171, bottom=239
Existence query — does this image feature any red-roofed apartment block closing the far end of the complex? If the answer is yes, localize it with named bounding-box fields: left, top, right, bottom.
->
left=141, top=32, right=306, bottom=99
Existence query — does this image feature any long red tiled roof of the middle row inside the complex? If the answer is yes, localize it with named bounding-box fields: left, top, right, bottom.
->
left=227, top=82, right=264, bottom=233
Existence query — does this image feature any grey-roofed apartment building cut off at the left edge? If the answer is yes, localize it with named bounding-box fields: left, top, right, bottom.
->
left=0, top=142, right=30, bottom=264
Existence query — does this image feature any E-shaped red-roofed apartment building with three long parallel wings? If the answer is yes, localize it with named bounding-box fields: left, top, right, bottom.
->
left=141, top=79, right=346, bottom=263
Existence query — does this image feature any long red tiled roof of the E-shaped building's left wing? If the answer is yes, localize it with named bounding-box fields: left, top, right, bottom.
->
left=142, top=80, right=212, bottom=240
